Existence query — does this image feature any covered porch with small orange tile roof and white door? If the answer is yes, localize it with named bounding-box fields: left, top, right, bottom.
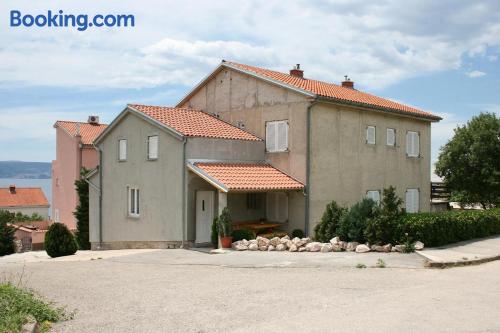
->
left=187, top=161, right=305, bottom=244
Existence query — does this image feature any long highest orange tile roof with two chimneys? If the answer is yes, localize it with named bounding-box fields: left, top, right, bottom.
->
left=223, top=61, right=441, bottom=120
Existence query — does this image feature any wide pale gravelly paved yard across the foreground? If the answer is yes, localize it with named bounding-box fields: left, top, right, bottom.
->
left=0, top=250, right=500, bottom=332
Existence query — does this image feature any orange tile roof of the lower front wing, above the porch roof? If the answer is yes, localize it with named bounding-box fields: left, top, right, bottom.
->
left=128, top=104, right=262, bottom=141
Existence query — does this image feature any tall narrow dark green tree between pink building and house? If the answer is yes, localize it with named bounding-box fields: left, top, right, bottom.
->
left=73, top=169, right=90, bottom=250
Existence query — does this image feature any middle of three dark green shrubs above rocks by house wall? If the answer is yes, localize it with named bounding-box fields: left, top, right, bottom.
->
left=337, top=198, right=378, bottom=243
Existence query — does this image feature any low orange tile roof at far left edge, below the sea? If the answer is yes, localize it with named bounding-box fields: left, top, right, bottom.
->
left=0, top=187, right=49, bottom=207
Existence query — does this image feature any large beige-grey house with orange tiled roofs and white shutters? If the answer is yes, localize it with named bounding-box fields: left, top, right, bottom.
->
left=89, top=61, right=440, bottom=248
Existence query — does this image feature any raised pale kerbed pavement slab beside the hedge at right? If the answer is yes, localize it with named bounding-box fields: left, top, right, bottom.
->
left=419, top=236, right=500, bottom=265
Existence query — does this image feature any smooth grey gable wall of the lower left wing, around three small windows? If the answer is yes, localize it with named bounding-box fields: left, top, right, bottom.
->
left=94, top=114, right=184, bottom=244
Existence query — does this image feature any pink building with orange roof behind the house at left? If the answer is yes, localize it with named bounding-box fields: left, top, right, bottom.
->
left=52, top=116, right=108, bottom=229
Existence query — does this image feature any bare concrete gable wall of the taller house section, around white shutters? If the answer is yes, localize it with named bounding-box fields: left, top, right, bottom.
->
left=183, top=69, right=309, bottom=182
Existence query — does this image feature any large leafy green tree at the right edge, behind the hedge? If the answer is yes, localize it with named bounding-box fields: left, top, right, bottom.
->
left=436, top=113, right=500, bottom=208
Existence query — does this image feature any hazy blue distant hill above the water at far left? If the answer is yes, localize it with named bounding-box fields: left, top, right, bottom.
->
left=0, top=161, right=51, bottom=179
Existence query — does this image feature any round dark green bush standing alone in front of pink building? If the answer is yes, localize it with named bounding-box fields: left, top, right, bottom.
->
left=45, top=223, right=77, bottom=258
